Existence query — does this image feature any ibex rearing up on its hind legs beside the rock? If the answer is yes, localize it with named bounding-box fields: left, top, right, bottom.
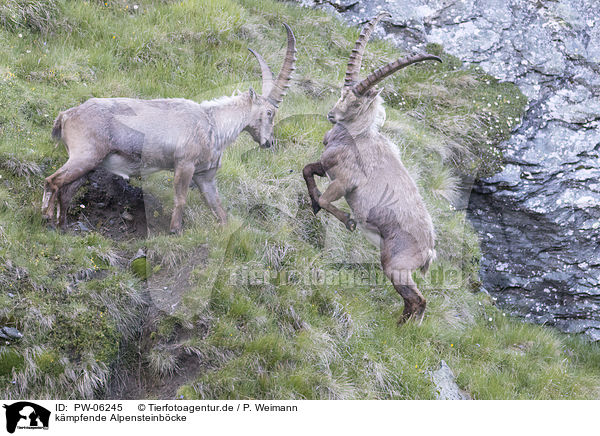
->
left=303, top=13, right=441, bottom=323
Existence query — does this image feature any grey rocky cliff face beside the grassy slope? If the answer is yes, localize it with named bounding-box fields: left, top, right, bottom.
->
left=302, top=0, right=600, bottom=340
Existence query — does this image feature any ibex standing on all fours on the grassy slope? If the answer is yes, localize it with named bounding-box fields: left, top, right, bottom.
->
left=42, top=24, right=296, bottom=232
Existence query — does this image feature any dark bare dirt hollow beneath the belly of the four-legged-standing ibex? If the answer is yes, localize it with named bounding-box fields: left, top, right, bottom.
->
left=68, top=169, right=169, bottom=241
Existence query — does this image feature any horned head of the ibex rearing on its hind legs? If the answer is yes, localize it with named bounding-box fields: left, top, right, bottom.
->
left=327, top=12, right=442, bottom=127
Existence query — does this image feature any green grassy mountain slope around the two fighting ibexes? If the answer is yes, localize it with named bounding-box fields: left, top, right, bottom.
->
left=0, top=0, right=600, bottom=399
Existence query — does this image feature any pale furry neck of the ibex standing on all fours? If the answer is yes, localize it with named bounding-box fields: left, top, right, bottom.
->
left=202, top=92, right=252, bottom=150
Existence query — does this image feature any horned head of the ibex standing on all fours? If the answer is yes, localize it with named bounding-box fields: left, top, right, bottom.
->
left=245, top=23, right=296, bottom=148
